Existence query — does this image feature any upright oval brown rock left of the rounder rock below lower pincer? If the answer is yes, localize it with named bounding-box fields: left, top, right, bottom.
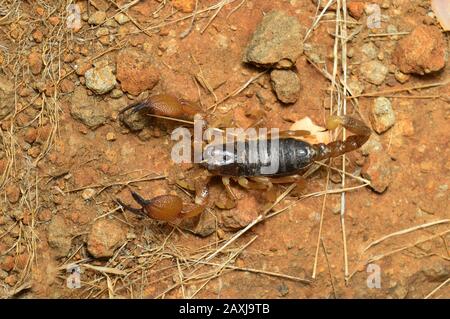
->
left=48, top=215, right=72, bottom=257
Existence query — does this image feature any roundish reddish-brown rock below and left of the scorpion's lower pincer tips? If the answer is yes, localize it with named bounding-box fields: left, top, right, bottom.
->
left=87, top=219, right=128, bottom=258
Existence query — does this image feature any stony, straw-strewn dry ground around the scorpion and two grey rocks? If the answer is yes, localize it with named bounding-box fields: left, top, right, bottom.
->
left=0, top=0, right=450, bottom=298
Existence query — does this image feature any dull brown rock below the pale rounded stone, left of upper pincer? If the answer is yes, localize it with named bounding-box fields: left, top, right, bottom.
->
left=70, top=87, right=107, bottom=129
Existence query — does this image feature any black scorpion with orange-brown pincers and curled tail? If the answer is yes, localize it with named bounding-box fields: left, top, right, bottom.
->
left=117, top=94, right=371, bottom=222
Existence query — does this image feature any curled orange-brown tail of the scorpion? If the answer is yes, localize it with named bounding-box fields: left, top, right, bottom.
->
left=312, top=116, right=371, bottom=161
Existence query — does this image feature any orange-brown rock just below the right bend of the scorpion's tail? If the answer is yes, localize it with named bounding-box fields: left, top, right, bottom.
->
left=361, top=152, right=392, bottom=194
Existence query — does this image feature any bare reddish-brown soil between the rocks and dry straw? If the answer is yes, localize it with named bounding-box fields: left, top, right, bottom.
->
left=0, top=0, right=450, bottom=298
